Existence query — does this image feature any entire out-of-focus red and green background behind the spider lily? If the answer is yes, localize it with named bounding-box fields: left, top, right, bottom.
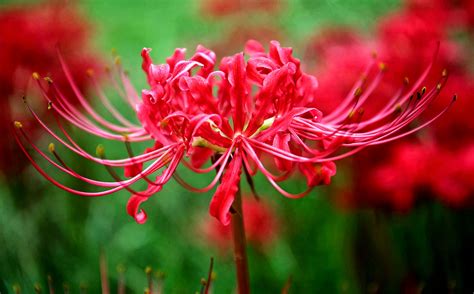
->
left=0, top=0, right=474, bottom=293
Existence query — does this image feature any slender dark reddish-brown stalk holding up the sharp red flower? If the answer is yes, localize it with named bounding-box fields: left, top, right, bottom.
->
left=231, top=187, right=250, bottom=294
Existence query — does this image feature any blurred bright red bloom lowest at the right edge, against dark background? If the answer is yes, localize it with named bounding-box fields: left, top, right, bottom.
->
left=355, top=142, right=474, bottom=211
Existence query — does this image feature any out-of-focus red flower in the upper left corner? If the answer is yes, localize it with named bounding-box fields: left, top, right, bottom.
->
left=0, top=3, right=98, bottom=174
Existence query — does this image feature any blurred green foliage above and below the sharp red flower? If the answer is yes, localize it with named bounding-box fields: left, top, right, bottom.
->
left=0, top=0, right=474, bottom=293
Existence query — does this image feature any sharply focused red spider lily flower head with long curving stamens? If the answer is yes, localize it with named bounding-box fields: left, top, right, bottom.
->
left=15, top=41, right=451, bottom=225
